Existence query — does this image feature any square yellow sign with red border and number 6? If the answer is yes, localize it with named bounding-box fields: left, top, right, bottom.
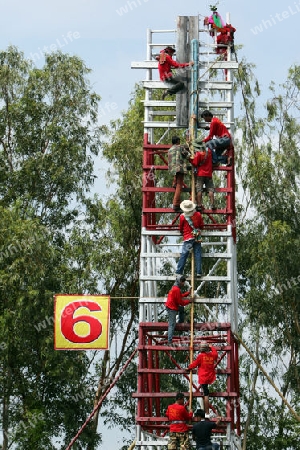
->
left=54, top=294, right=110, bottom=350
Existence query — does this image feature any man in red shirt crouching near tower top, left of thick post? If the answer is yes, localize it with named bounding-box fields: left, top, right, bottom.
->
left=157, top=47, right=194, bottom=100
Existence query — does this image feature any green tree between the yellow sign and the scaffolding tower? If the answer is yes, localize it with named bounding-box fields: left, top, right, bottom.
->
left=79, top=86, right=144, bottom=450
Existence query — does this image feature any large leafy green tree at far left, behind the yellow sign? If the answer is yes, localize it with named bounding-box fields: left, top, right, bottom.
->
left=0, top=46, right=102, bottom=450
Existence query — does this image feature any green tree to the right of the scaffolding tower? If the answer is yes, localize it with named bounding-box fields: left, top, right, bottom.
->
left=236, top=61, right=300, bottom=449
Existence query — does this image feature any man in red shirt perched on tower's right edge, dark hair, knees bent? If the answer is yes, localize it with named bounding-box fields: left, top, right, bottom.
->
left=201, top=109, right=232, bottom=164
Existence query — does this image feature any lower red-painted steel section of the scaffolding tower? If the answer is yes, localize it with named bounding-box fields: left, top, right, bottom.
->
left=133, top=322, right=240, bottom=436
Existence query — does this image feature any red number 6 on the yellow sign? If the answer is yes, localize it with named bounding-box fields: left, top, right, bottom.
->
left=60, top=301, right=102, bottom=344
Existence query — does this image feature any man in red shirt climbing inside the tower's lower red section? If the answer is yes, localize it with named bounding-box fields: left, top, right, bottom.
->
left=186, top=341, right=218, bottom=416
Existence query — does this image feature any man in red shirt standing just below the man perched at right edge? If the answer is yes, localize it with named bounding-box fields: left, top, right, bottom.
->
left=190, top=139, right=217, bottom=211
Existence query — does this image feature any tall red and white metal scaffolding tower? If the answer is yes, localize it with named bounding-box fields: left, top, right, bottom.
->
left=132, top=16, right=240, bottom=450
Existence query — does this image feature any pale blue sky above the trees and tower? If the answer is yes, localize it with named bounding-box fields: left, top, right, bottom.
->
left=0, top=0, right=300, bottom=450
